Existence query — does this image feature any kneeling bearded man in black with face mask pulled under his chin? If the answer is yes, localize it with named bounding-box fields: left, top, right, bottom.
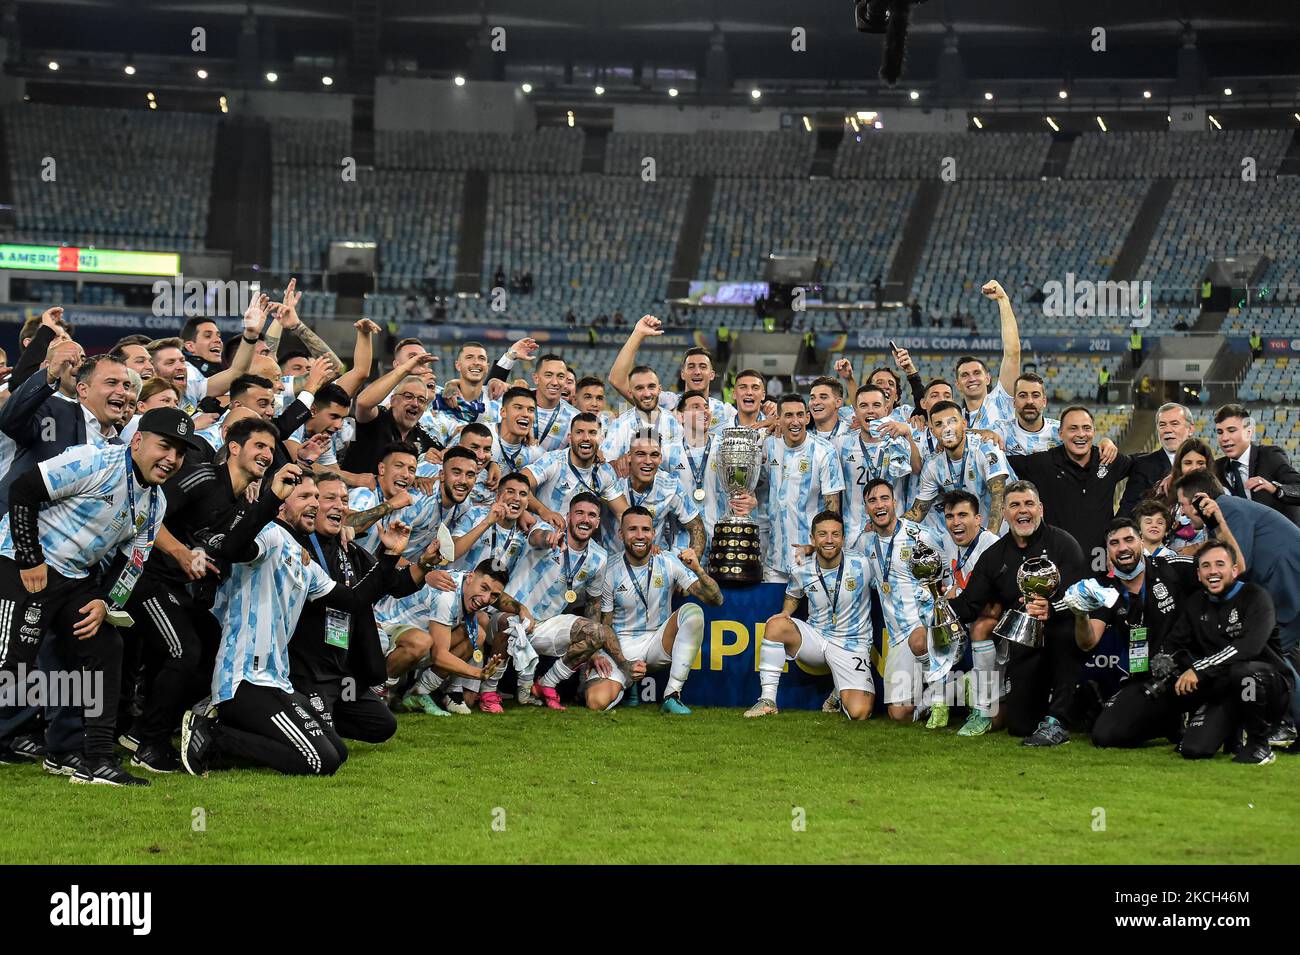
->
left=1074, top=517, right=1197, bottom=746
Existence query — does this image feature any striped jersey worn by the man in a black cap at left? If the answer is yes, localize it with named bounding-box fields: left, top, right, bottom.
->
left=0, top=444, right=166, bottom=578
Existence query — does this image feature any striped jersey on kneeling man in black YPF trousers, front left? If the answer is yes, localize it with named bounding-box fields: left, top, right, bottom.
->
left=212, top=524, right=334, bottom=703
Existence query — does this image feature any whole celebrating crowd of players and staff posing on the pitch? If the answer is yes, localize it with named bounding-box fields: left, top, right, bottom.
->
left=0, top=276, right=1300, bottom=786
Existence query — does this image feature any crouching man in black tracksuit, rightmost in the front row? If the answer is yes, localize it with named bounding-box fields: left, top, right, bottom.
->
left=1170, top=541, right=1295, bottom=764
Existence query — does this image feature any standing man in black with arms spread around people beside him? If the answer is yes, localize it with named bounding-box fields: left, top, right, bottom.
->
left=1008, top=405, right=1132, bottom=573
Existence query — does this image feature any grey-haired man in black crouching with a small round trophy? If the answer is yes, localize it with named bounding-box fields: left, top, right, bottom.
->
left=952, top=481, right=1087, bottom=746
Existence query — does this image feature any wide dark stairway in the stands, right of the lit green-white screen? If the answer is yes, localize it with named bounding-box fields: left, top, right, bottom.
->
left=207, top=117, right=273, bottom=269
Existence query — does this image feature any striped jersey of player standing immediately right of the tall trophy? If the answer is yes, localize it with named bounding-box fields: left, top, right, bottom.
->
left=763, top=434, right=844, bottom=574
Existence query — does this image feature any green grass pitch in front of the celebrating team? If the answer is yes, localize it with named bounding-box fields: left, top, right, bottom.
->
left=0, top=704, right=1300, bottom=864
